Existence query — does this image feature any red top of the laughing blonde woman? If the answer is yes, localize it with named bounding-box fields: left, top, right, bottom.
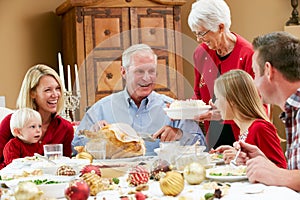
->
left=0, top=114, right=74, bottom=169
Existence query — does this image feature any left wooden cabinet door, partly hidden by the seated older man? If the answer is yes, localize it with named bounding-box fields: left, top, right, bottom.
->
left=84, top=8, right=130, bottom=106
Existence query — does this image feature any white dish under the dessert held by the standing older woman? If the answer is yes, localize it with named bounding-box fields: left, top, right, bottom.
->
left=164, top=105, right=211, bottom=119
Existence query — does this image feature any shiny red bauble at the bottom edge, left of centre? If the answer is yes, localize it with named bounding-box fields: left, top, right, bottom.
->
left=65, top=180, right=90, bottom=200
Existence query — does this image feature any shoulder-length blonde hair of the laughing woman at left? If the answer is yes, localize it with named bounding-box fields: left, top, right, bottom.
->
left=16, top=64, right=64, bottom=113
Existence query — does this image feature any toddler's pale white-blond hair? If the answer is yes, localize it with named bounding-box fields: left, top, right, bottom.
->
left=10, top=108, right=42, bottom=137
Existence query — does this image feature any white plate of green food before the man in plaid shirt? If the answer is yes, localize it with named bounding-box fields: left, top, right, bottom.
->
left=206, top=165, right=247, bottom=182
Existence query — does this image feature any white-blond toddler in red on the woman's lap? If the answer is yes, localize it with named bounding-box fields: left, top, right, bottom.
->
left=3, top=108, right=43, bottom=165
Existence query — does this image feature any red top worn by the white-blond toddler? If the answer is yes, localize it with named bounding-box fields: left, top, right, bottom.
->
left=3, top=138, right=43, bottom=166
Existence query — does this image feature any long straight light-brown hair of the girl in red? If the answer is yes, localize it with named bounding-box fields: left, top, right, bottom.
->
left=215, top=69, right=270, bottom=121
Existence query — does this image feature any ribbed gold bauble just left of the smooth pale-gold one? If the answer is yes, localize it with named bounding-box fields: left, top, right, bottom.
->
left=159, top=171, right=184, bottom=196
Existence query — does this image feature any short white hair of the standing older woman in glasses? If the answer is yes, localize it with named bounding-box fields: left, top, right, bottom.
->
left=188, top=0, right=231, bottom=32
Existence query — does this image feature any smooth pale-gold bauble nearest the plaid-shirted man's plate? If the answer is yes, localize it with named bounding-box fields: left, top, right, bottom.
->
left=183, top=162, right=205, bottom=185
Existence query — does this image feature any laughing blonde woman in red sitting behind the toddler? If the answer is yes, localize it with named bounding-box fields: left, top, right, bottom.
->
left=0, top=64, right=74, bottom=169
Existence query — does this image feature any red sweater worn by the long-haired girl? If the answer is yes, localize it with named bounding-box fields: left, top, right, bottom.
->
left=245, top=119, right=287, bottom=169
